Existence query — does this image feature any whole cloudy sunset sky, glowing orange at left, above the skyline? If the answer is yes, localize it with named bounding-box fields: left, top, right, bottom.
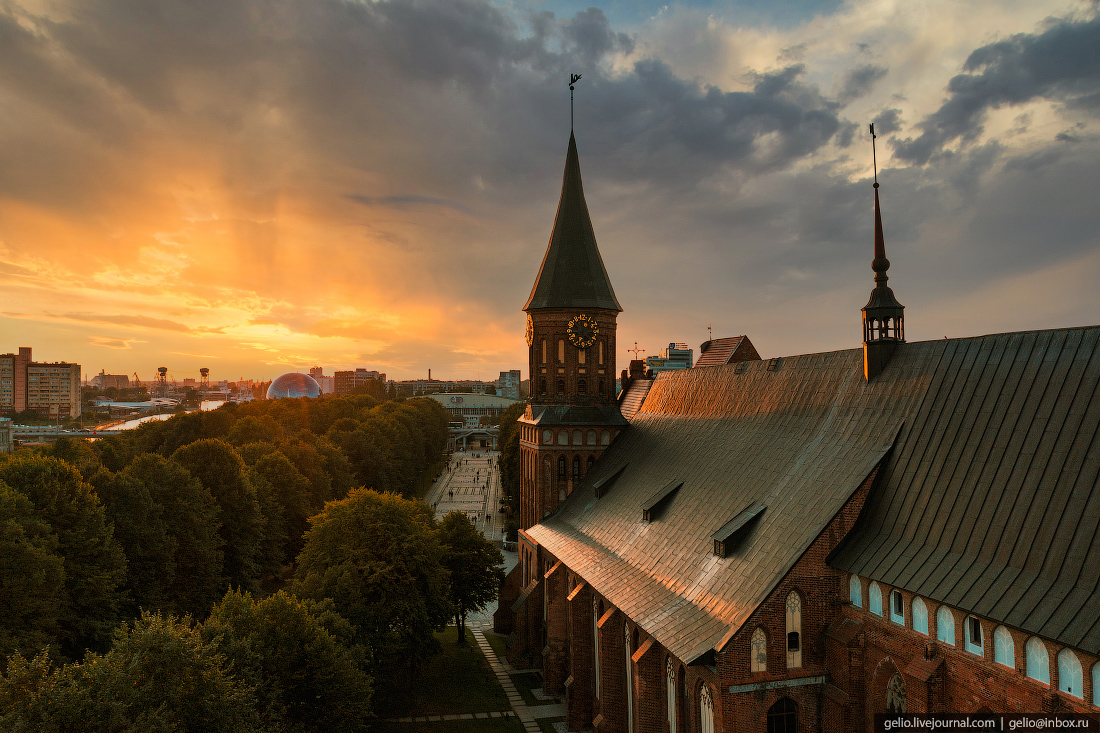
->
left=0, top=0, right=1100, bottom=380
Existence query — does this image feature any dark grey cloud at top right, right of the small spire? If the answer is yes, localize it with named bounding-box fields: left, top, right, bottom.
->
left=893, top=17, right=1100, bottom=164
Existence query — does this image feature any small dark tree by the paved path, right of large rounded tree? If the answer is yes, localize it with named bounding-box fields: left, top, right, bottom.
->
left=439, top=512, right=504, bottom=644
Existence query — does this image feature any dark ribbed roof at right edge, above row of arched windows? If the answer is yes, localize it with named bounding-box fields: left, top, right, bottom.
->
left=832, top=327, right=1100, bottom=654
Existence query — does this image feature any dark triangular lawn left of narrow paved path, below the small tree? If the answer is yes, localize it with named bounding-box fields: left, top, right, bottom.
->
left=375, top=626, right=512, bottom=717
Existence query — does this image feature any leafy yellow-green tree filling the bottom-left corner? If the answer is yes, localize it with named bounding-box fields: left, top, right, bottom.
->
left=0, top=613, right=263, bottom=733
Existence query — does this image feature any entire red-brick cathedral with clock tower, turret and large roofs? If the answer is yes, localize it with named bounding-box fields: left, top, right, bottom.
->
left=495, top=129, right=1100, bottom=733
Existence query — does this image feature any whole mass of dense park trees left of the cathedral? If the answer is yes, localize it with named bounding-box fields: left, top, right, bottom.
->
left=0, top=396, right=502, bottom=733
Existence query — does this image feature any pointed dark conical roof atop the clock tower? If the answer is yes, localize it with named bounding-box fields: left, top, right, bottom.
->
left=524, top=132, right=623, bottom=311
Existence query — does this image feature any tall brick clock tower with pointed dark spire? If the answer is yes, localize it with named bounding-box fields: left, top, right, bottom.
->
left=519, top=132, right=627, bottom=529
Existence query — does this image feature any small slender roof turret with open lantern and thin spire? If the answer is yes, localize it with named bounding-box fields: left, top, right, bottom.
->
left=864, top=122, right=905, bottom=381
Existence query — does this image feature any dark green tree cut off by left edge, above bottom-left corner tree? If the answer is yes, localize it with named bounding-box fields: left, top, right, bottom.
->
left=0, top=482, right=65, bottom=658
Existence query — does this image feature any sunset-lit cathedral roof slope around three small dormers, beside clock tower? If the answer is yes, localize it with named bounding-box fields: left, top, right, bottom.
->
left=527, top=341, right=945, bottom=661
